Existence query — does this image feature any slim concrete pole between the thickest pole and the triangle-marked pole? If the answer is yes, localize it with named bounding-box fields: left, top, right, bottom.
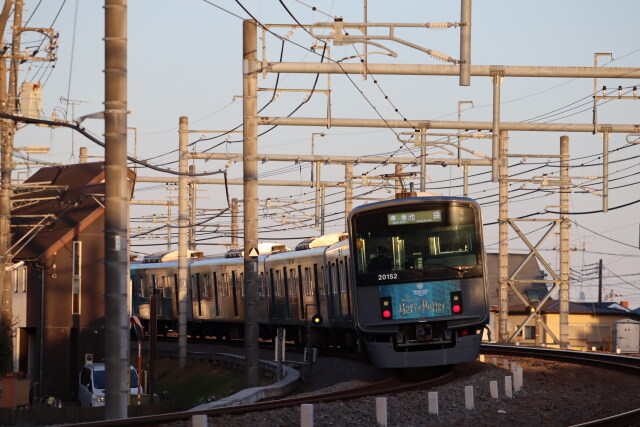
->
left=178, top=116, right=189, bottom=369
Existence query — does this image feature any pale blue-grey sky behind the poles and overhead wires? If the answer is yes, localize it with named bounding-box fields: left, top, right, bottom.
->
left=5, top=0, right=640, bottom=308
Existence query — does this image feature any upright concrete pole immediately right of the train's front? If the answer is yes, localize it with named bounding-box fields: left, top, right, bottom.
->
left=498, top=130, right=509, bottom=342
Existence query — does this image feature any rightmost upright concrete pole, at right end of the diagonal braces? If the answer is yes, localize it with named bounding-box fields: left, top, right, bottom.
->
left=560, top=136, right=571, bottom=349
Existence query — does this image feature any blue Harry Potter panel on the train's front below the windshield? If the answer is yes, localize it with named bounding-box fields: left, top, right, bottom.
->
left=379, top=280, right=461, bottom=320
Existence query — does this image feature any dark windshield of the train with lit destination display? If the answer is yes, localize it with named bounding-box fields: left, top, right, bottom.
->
left=352, top=203, right=482, bottom=281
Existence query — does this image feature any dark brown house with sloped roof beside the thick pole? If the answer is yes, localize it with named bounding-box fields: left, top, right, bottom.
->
left=11, top=162, right=135, bottom=398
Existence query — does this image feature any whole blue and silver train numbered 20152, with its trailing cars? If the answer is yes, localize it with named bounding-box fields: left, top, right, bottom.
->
left=131, top=196, right=489, bottom=368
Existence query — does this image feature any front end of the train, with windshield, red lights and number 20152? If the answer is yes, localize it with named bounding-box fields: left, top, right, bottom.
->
left=349, top=197, right=489, bottom=368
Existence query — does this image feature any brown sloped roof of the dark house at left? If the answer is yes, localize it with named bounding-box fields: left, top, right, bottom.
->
left=11, top=162, right=135, bottom=261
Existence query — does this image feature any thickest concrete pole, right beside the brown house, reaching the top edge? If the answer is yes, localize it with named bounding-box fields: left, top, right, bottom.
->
left=104, top=0, right=129, bottom=419
